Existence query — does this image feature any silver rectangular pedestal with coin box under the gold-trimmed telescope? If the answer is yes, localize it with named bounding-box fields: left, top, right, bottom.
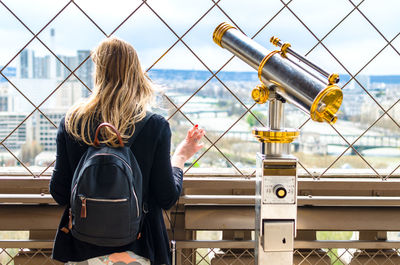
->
left=255, top=154, right=297, bottom=265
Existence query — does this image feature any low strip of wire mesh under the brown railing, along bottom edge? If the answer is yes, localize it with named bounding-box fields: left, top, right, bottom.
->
left=0, top=245, right=400, bottom=265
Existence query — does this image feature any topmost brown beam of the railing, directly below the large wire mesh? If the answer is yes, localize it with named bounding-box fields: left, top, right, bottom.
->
left=0, top=173, right=400, bottom=196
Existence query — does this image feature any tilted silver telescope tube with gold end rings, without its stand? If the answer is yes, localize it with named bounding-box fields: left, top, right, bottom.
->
left=213, top=23, right=343, bottom=124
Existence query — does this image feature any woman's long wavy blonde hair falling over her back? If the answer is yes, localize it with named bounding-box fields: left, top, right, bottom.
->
left=65, top=37, right=154, bottom=146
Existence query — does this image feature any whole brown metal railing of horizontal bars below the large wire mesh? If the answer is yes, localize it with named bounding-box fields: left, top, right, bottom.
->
left=0, top=169, right=400, bottom=265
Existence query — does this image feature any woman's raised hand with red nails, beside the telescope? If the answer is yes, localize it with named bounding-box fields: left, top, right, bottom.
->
left=171, top=124, right=205, bottom=169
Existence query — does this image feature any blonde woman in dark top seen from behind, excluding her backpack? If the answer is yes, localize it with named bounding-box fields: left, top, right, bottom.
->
left=50, top=38, right=204, bottom=265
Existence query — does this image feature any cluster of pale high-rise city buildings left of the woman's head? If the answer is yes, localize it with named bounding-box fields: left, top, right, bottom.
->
left=0, top=45, right=93, bottom=165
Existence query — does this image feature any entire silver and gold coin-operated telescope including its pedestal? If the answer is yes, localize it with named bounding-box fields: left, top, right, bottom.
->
left=213, top=23, right=343, bottom=265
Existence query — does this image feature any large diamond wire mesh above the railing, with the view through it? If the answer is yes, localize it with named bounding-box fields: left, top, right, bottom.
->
left=0, top=0, right=400, bottom=179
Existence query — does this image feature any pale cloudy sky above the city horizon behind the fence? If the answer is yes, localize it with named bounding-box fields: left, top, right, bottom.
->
left=0, top=0, right=400, bottom=75
